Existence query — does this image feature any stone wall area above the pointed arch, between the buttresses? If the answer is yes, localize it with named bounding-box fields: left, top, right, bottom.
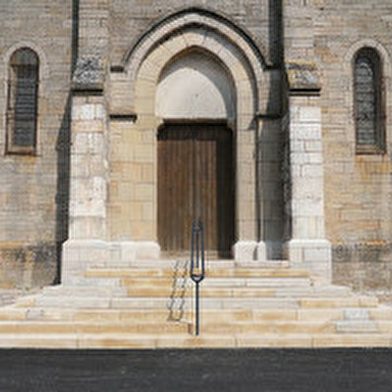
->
left=110, top=0, right=280, bottom=66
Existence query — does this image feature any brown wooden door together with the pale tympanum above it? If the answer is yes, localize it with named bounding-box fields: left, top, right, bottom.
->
left=156, top=49, right=236, bottom=258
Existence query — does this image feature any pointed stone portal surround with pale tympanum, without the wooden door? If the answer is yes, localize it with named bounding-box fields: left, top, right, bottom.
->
left=111, top=11, right=269, bottom=259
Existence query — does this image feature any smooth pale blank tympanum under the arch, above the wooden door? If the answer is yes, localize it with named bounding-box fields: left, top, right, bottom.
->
left=155, top=48, right=236, bottom=125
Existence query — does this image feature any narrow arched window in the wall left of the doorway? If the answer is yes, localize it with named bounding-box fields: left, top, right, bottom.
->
left=7, top=48, right=39, bottom=154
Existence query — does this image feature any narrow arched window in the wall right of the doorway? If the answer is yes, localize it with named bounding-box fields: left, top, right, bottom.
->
left=354, top=48, right=385, bottom=154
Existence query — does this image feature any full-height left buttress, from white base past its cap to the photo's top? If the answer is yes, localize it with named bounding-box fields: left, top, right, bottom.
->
left=62, top=0, right=110, bottom=284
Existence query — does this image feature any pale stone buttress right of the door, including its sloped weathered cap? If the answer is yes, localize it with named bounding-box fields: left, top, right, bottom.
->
left=285, top=64, right=331, bottom=283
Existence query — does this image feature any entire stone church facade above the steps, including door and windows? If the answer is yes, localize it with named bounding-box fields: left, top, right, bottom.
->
left=0, top=0, right=392, bottom=296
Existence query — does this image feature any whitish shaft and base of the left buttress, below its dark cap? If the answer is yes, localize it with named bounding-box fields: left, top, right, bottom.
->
left=62, top=95, right=108, bottom=283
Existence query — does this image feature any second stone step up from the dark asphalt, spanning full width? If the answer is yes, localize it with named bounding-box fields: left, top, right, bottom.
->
left=0, top=317, right=392, bottom=335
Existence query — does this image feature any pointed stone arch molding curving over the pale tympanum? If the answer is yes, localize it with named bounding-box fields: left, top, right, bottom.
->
left=111, top=10, right=270, bottom=114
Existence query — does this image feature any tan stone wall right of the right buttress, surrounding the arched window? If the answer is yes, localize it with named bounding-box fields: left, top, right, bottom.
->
left=298, top=0, right=392, bottom=290
